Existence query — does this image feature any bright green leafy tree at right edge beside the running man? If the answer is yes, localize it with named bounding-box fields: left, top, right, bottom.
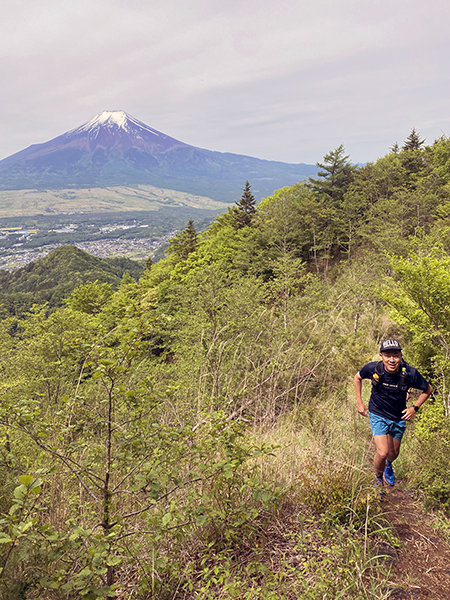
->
left=384, top=244, right=450, bottom=511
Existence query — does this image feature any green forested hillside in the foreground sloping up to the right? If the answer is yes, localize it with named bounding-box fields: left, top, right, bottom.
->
left=0, top=131, right=450, bottom=600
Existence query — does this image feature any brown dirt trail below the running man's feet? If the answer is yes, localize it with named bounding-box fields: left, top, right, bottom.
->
left=383, top=482, right=450, bottom=600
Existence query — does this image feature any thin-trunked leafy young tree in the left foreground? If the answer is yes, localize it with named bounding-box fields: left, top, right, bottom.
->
left=0, top=314, right=274, bottom=599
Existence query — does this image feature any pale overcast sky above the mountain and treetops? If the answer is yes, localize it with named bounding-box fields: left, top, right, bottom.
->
left=0, top=0, right=450, bottom=163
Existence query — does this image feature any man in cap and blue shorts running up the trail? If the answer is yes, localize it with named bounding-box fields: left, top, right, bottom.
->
left=354, top=339, right=433, bottom=498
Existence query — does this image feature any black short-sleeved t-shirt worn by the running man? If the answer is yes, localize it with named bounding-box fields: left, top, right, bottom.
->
left=359, top=362, right=428, bottom=421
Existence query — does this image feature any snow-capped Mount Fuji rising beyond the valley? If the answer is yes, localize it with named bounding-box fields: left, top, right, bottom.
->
left=0, top=111, right=317, bottom=202
